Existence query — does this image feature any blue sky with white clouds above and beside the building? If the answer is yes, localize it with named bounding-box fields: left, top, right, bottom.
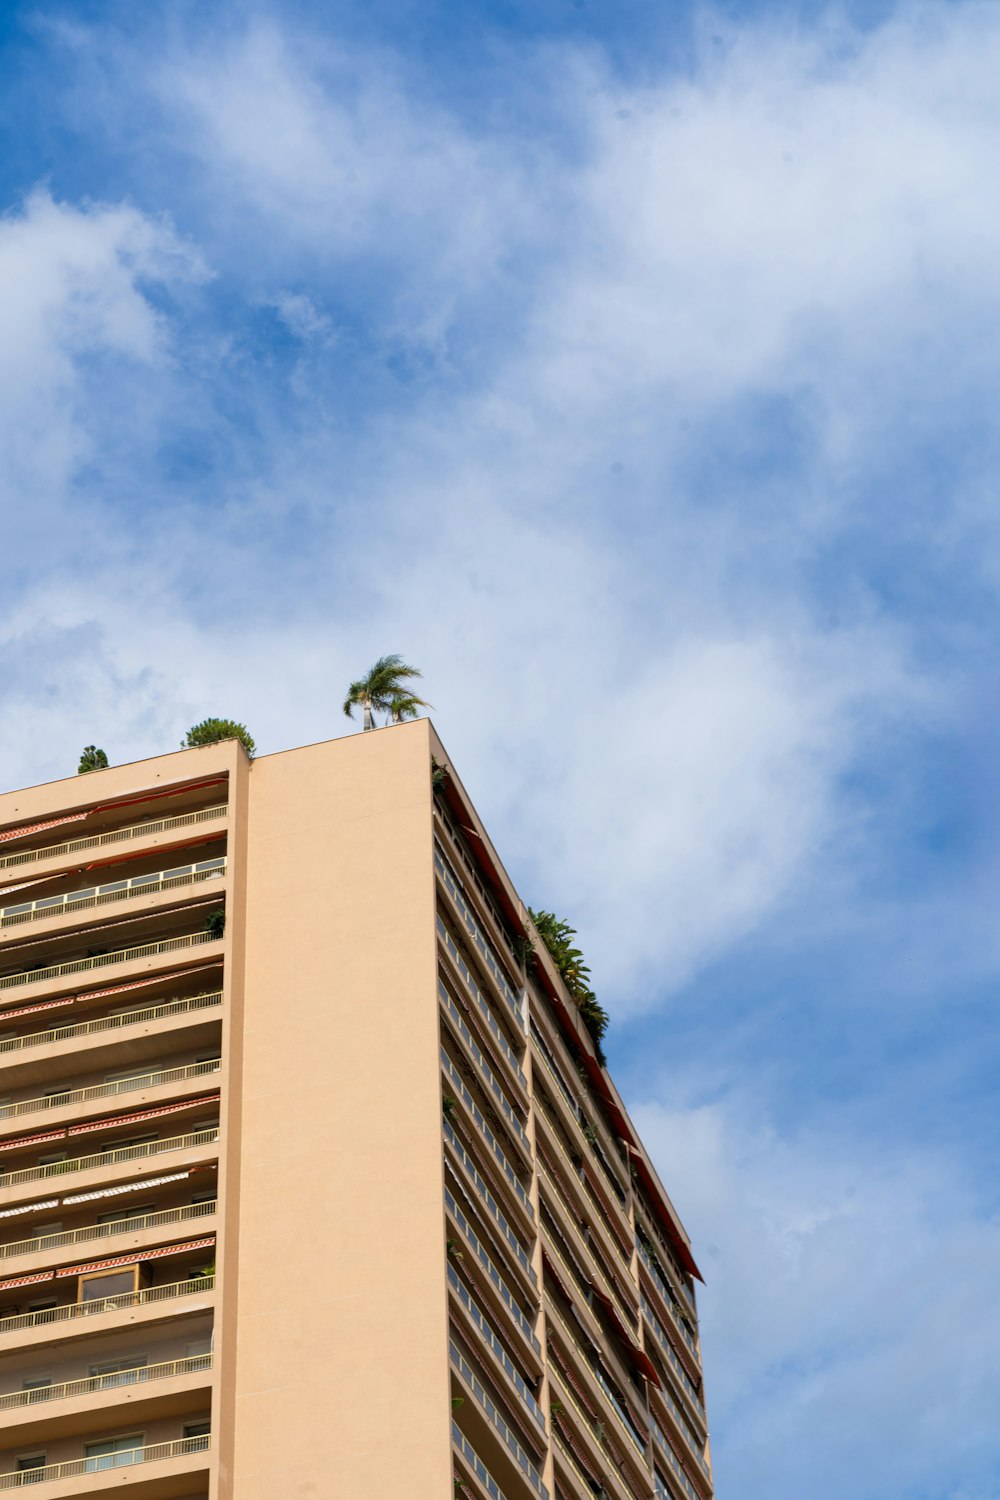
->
left=0, top=0, right=1000, bottom=1500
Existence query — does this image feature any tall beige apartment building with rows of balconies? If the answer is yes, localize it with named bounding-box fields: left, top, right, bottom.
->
left=0, top=722, right=712, bottom=1500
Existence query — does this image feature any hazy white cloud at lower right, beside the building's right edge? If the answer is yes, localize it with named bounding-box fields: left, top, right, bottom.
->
left=633, top=1100, right=1000, bottom=1500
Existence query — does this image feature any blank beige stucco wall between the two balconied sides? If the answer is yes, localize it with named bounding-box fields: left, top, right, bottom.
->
left=229, top=722, right=451, bottom=1500
